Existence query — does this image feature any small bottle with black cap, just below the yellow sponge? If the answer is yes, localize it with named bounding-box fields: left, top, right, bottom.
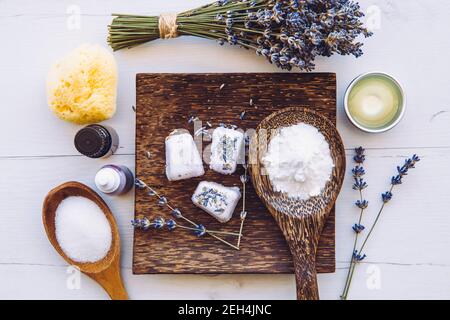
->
left=74, top=124, right=119, bottom=158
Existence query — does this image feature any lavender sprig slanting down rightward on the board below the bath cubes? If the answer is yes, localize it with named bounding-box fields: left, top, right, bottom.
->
left=132, top=178, right=240, bottom=250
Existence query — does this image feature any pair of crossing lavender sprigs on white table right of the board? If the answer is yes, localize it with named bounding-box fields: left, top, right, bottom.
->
left=341, top=147, right=420, bottom=300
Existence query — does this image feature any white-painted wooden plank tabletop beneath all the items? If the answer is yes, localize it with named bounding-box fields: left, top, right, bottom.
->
left=0, top=0, right=450, bottom=299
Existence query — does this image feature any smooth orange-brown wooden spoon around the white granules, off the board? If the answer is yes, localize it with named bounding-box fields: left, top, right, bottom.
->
left=42, top=181, right=128, bottom=300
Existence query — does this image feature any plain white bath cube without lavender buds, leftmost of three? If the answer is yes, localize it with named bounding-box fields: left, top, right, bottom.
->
left=166, top=131, right=205, bottom=181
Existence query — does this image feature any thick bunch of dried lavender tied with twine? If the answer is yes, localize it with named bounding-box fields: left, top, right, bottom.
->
left=108, top=0, right=371, bottom=71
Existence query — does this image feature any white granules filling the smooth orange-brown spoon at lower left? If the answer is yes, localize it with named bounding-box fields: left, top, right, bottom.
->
left=55, top=196, right=112, bottom=263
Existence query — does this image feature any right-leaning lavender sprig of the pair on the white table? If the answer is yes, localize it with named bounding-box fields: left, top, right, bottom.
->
left=341, top=152, right=420, bottom=300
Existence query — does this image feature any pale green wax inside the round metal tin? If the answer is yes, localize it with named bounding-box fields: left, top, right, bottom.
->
left=348, top=74, right=403, bottom=129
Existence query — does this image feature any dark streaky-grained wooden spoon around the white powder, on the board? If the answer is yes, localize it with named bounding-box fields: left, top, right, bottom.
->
left=249, top=108, right=345, bottom=300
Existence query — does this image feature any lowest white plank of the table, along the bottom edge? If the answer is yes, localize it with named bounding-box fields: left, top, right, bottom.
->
left=0, top=264, right=450, bottom=300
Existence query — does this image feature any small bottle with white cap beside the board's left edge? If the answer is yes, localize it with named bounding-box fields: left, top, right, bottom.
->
left=95, top=164, right=134, bottom=195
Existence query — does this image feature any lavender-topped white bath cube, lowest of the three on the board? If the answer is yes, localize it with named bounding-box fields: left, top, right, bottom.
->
left=192, top=181, right=241, bottom=223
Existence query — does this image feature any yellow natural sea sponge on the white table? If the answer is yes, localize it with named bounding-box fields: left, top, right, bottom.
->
left=47, top=44, right=117, bottom=124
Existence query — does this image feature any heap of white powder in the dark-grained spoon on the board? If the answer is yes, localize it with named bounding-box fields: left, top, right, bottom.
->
left=262, top=123, right=334, bottom=200
